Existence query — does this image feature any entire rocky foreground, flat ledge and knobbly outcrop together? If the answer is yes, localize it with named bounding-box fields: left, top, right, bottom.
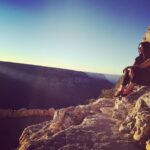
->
left=18, top=86, right=150, bottom=150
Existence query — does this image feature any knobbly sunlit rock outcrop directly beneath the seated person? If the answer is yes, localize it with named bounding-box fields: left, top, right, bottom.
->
left=113, top=86, right=150, bottom=149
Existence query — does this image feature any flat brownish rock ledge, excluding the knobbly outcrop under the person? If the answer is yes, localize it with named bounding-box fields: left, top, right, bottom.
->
left=18, top=98, right=140, bottom=150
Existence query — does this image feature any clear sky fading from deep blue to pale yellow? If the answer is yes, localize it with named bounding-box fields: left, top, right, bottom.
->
left=0, top=0, right=150, bottom=74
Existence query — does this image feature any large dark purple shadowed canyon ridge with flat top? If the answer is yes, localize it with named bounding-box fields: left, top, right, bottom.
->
left=0, top=62, right=113, bottom=109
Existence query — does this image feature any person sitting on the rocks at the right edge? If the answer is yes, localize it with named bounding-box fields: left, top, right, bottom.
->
left=114, top=41, right=150, bottom=96
